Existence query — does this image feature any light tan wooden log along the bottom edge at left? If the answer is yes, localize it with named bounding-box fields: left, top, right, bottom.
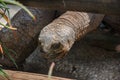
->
left=0, top=70, right=73, bottom=80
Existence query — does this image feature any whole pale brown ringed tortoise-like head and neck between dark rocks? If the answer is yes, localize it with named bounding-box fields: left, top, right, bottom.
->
left=39, top=11, right=104, bottom=59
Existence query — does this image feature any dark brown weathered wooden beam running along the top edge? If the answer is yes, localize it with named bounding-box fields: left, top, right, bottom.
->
left=18, top=0, right=120, bottom=15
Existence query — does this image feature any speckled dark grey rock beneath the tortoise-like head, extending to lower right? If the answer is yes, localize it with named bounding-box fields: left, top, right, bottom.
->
left=24, top=32, right=120, bottom=80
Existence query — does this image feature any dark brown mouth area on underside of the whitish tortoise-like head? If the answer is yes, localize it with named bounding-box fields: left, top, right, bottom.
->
left=39, top=43, right=68, bottom=60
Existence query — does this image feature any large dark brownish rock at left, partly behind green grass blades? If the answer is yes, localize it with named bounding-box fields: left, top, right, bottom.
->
left=0, top=8, right=55, bottom=66
